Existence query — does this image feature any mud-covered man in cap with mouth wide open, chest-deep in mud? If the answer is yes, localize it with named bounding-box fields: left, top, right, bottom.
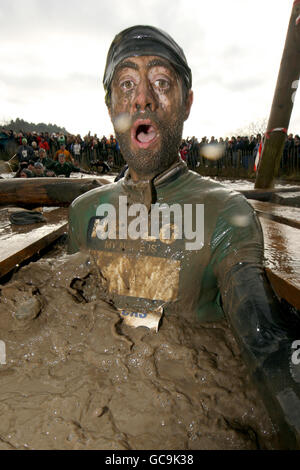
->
left=69, top=26, right=300, bottom=446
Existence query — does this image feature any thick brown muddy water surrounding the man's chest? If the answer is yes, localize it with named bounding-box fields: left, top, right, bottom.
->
left=0, top=254, right=277, bottom=449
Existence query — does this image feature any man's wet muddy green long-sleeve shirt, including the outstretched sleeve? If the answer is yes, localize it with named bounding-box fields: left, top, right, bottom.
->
left=69, top=163, right=300, bottom=448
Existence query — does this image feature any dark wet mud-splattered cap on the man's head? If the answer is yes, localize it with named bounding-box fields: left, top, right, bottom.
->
left=103, top=25, right=192, bottom=97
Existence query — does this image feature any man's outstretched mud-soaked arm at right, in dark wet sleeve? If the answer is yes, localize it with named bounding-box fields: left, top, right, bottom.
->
left=212, top=196, right=300, bottom=448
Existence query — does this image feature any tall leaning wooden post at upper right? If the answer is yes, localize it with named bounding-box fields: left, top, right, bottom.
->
left=255, top=0, right=300, bottom=189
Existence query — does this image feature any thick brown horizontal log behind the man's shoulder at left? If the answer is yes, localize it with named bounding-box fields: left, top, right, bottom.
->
left=0, top=178, right=110, bottom=208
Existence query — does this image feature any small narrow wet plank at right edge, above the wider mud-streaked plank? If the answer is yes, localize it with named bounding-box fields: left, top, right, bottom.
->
left=248, top=199, right=300, bottom=229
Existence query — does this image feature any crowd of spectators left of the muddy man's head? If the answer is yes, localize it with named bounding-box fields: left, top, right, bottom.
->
left=0, top=130, right=116, bottom=178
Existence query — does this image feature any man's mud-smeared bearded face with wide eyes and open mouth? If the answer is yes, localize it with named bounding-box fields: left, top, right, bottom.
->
left=102, top=26, right=193, bottom=177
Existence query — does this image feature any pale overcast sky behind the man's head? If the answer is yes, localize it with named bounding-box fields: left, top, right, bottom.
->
left=0, top=0, right=300, bottom=138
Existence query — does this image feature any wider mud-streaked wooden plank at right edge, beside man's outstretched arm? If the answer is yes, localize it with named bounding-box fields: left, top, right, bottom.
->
left=260, top=218, right=300, bottom=310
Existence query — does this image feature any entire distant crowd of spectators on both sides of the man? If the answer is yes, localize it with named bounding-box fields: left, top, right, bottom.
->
left=0, top=129, right=300, bottom=177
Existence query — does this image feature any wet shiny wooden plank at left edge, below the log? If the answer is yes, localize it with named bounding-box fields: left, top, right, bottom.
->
left=0, top=208, right=68, bottom=278
